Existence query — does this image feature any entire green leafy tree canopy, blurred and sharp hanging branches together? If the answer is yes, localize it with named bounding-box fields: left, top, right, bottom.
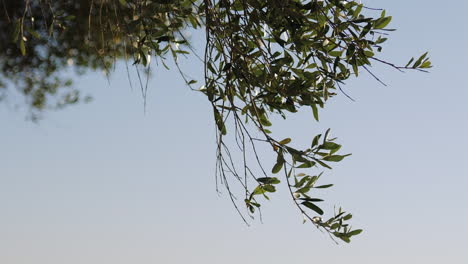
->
left=0, top=0, right=431, bottom=242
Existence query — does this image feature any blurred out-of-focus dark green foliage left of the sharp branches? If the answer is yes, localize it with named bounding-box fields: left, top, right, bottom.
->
left=0, top=0, right=199, bottom=117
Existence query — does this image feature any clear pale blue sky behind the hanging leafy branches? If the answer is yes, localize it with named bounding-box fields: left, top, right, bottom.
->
left=0, top=0, right=468, bottom=264
